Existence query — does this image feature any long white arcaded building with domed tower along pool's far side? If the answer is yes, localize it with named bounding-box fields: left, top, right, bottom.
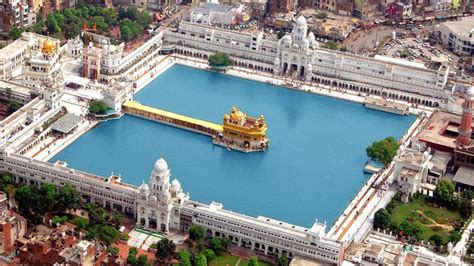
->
left=164, top=17, right=451, bottom=106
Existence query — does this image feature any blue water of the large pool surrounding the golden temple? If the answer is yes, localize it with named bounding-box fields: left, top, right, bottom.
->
left=51, top=66, right=415, bottom=226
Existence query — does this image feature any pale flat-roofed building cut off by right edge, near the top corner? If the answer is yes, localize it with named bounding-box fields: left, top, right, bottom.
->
left=436, top=16, right=474, bottom=56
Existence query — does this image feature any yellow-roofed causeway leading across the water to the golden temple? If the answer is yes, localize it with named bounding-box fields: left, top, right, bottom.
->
left=123, top=101, right=223, bottom=137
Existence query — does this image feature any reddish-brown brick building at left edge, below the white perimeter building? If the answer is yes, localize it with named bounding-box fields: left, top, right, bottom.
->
left=0, top=192, right=27, bottom=254
